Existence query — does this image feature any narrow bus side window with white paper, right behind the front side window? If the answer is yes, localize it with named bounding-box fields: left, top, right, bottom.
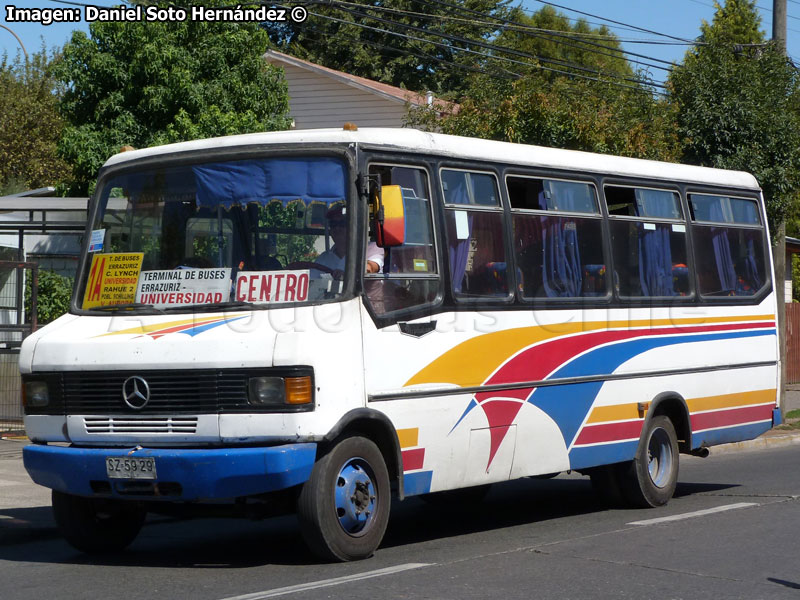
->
left=441, top=169, right=509, bottom=299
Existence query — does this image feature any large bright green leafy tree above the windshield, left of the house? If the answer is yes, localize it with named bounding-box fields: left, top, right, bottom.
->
left=56, top=0, right=289, bottom=194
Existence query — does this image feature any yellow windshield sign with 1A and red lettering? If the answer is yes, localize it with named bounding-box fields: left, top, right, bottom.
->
left=83, top=252, right=144, bottom=308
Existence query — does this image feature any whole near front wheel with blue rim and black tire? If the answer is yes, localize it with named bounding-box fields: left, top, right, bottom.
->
left=297, top=437, right=391, bottom=561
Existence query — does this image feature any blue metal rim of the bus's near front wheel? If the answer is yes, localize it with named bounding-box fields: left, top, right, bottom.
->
left=335, top=458, right=378, bottom=537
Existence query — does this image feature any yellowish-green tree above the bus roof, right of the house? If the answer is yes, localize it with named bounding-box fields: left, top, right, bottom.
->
left=408, top=7, right=679, bottom=160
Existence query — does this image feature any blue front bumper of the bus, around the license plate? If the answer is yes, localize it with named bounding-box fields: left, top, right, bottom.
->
left=23, top=443, right=317, bottom=501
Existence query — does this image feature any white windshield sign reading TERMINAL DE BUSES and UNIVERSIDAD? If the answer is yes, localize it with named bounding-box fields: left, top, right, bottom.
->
left=136, top=268, right=231, bottom=307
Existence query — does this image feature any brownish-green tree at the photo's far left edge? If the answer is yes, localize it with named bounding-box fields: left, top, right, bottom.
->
left=0, top=49, right=69, bottom=195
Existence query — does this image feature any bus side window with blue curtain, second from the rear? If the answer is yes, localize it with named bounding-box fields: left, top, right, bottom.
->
left=605, top=186, right=692, bottom=298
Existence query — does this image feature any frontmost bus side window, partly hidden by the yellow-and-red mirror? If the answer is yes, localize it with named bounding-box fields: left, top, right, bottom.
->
left=364, top=165, right=439, bottom=314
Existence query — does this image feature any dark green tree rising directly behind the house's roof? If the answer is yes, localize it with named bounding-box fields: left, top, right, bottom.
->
left=266, top=0, right=512, bottom=94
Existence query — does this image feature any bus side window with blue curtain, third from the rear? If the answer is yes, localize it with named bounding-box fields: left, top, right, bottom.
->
left=506, top=176, right=608, bottom=299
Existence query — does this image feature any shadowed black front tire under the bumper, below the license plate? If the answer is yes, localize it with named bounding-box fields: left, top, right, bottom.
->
left=52, top=490, right=146, bottom=554
